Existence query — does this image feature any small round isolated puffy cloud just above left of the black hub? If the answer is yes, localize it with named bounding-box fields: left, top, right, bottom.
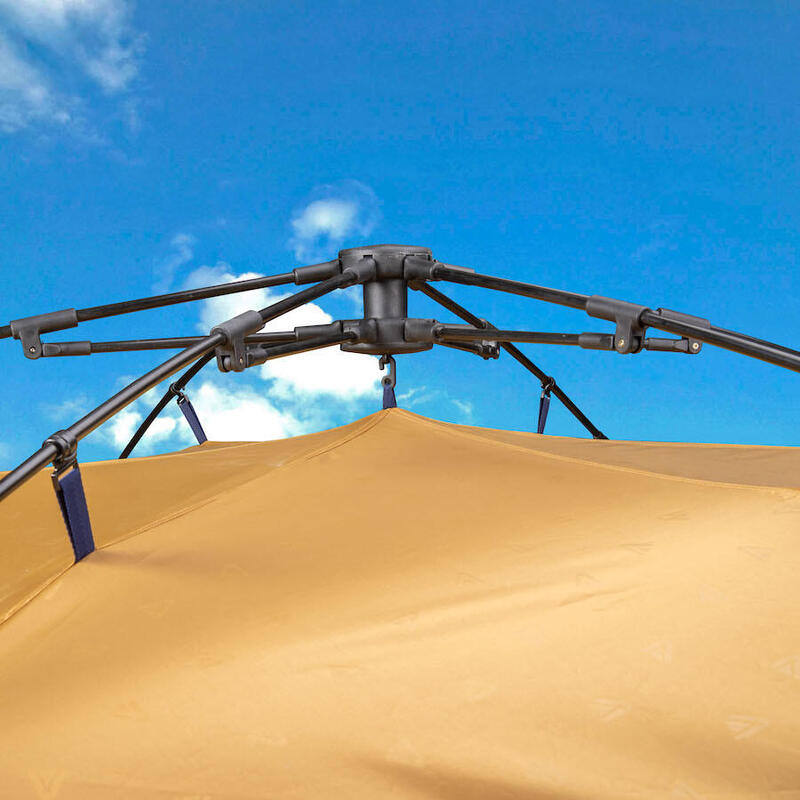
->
left=289, top=180, right=381, bottom=262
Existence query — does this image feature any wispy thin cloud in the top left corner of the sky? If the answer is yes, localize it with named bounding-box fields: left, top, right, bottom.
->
left=0, top=0, right=144, bottom=138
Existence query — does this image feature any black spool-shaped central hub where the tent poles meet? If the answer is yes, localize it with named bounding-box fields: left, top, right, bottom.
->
left=339, top=244, right=433, bottom=356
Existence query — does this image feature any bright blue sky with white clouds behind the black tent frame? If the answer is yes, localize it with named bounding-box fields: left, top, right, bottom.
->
left=0, top=0, right=800, bottom=467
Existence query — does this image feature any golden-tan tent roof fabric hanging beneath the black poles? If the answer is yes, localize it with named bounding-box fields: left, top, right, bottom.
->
left=0, top=409, right=800, bottom=800
